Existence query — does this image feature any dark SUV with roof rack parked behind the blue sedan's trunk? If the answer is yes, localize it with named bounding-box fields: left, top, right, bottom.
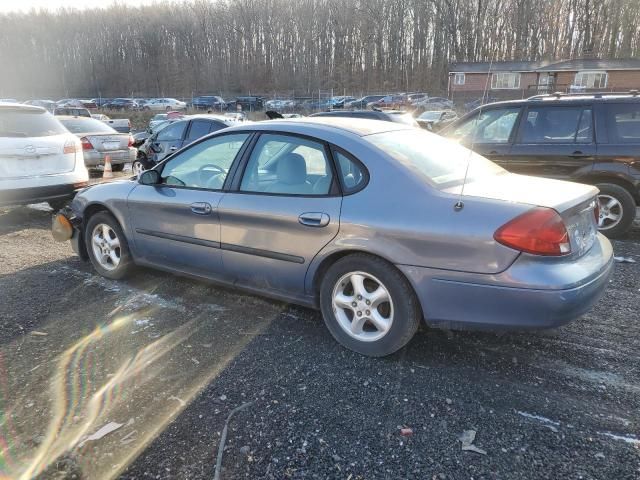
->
left=441, top=92, right=640, bottom=238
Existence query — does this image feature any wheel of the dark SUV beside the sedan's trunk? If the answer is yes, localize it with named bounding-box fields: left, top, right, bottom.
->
left=596, top=183, right=636, bottom=238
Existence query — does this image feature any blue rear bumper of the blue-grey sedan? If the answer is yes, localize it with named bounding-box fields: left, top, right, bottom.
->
left=398, top=235, right=613, bottom=329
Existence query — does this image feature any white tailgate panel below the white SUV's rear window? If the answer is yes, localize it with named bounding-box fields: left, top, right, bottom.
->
left=0, top=134, right=77, bottom=180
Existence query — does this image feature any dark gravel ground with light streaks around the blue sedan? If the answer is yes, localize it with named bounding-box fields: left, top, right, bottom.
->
left=0, top=197, right=640, bottom=480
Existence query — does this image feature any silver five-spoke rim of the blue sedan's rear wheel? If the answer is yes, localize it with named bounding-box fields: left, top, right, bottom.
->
left=332, top=272, right=393, bottom=342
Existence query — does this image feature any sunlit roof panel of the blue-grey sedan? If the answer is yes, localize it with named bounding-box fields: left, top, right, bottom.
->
left=225, top=116, right=413, bottom=137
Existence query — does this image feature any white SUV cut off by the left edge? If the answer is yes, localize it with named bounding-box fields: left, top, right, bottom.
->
left=0, top=104, right=89, bottom=209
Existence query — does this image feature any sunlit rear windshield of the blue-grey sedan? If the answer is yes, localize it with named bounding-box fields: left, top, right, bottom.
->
left=365, top=129, right=505, bottom=188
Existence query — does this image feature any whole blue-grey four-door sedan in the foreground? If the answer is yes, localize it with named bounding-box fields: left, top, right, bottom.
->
left=53, top=118, right=612, bottom=356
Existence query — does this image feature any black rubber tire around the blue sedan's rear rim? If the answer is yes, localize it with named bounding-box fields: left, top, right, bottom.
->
left=320, top=253, right=422, bottom=357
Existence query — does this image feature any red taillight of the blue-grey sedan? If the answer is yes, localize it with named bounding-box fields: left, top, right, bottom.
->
left=493, top=207, right=571, bottom=256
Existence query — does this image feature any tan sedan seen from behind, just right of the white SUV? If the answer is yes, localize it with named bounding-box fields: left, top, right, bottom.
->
left=58, top=117, right=136, bottom=172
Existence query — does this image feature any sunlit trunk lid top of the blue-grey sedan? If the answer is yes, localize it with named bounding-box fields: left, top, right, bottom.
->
left=445, top=173, right=598, bottom=212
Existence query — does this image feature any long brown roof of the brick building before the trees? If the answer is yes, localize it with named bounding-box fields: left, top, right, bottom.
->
left=449, top=58, right=640, bottom=73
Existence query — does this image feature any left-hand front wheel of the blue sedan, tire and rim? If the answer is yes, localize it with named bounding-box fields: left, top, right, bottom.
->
left=84, top=212, right=133, bottom=280
